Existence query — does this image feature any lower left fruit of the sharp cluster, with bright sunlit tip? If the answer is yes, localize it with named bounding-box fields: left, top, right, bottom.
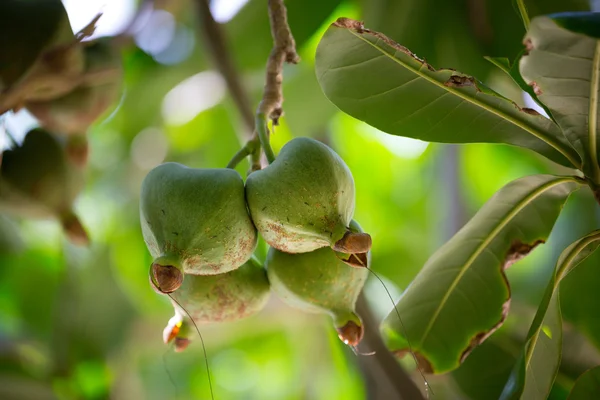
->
left=157, top=258, right=270, bottom=351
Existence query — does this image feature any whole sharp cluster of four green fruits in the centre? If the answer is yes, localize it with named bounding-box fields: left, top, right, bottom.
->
left=140, top=138, right=371, bottom=350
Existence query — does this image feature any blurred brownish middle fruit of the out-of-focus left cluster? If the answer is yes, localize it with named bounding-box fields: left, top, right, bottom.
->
left=25, top=39, right=123, bottom=135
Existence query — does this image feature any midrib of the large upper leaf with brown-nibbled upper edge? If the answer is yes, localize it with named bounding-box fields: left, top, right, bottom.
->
left=342, top=28, right=581, bottom=169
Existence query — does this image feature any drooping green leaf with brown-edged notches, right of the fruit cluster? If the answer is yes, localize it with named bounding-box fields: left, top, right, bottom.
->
left=381, top=175, right=580, bottom=373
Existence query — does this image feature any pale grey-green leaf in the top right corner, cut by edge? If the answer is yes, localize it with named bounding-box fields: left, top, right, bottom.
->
left=519, top=13, right=600, bottom=183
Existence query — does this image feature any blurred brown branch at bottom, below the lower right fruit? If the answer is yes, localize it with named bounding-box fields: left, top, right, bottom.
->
left=356, top=295, right=423, bottom=400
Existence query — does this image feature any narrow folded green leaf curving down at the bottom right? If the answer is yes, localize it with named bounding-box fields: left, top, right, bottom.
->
left=501, top=231, right=600, bottom=400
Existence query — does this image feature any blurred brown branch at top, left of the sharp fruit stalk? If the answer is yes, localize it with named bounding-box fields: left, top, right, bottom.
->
left=196, top=0, right=254, bottom=133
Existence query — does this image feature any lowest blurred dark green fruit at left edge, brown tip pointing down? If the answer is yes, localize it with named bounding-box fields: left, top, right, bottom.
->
left=0, top=129, right=88, bottom=244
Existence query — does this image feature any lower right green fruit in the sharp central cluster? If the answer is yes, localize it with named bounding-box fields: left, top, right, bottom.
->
left=266, top=228, right=369, bottom=346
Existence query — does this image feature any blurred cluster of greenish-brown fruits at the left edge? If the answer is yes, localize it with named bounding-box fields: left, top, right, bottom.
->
left=0, top=0, right=123, bottom=244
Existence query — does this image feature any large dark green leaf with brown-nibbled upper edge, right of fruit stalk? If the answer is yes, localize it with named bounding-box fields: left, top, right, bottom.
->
left=316, top=18, right=581, bottom=167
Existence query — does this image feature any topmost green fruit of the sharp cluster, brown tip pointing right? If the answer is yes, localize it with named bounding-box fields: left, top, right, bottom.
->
left=246, top=138, right=371, bottom=253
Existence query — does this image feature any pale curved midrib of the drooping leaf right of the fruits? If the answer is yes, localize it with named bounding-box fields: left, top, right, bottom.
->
left=420, top=177, right=577, bottom=346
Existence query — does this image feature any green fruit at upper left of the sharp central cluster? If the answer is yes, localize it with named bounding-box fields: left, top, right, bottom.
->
left=140, top=162, right=257, bottom=293
